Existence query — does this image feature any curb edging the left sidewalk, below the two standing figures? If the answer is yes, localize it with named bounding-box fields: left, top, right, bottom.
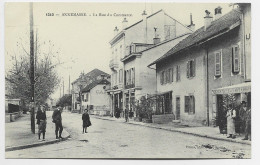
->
left=5, top=133, right=70, bottom=152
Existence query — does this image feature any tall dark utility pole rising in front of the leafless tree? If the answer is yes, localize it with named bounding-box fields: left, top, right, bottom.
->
left=30, top=2, right=35, bottom=134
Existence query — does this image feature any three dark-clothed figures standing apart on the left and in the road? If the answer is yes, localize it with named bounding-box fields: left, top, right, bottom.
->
left=36, top=105, right=92, bottom=141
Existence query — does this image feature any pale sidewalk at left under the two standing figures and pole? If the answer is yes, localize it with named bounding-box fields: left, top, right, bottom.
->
left=5, top=111, right=70, bottom=151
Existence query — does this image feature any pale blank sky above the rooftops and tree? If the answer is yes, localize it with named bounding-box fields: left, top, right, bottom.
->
left=5, top=2, right=232, bottom=98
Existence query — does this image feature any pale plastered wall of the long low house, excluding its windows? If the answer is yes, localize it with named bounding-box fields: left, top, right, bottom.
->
left=156, top=49, right=206, bottom=125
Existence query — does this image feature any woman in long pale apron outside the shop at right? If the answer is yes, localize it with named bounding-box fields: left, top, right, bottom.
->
left=226, top=106, right=236, bottom=139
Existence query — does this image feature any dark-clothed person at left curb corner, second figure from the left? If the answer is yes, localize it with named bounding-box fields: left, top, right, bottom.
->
left=52, top=107, right=63, bottom=139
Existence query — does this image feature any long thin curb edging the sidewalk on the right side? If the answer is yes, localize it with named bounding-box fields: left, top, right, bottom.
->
left=93, top=116, right=251, bottom=145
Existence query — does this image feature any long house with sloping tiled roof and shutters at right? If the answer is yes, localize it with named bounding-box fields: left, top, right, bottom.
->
left=149, top=4, right=251, bottom=125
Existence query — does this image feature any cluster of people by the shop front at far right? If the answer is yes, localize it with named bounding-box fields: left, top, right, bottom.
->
left=226, top=101, right=251, bottom=140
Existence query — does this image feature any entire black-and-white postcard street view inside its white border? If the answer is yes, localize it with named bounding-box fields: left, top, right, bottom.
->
left=4, top=2, right=252, bottom=159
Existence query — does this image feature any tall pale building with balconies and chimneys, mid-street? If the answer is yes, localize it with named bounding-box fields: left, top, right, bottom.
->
left=108, top=10, right=194, bottom=116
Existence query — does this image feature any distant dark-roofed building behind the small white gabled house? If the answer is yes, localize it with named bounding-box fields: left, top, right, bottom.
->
left=71, top=69, right=110, bottom=112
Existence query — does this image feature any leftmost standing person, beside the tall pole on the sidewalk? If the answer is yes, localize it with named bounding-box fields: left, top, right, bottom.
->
left=36, top=105, right=47, bottom=141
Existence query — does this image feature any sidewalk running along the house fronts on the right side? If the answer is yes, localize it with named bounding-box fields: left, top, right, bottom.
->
left=91, top=115, right=251, bottom=145
